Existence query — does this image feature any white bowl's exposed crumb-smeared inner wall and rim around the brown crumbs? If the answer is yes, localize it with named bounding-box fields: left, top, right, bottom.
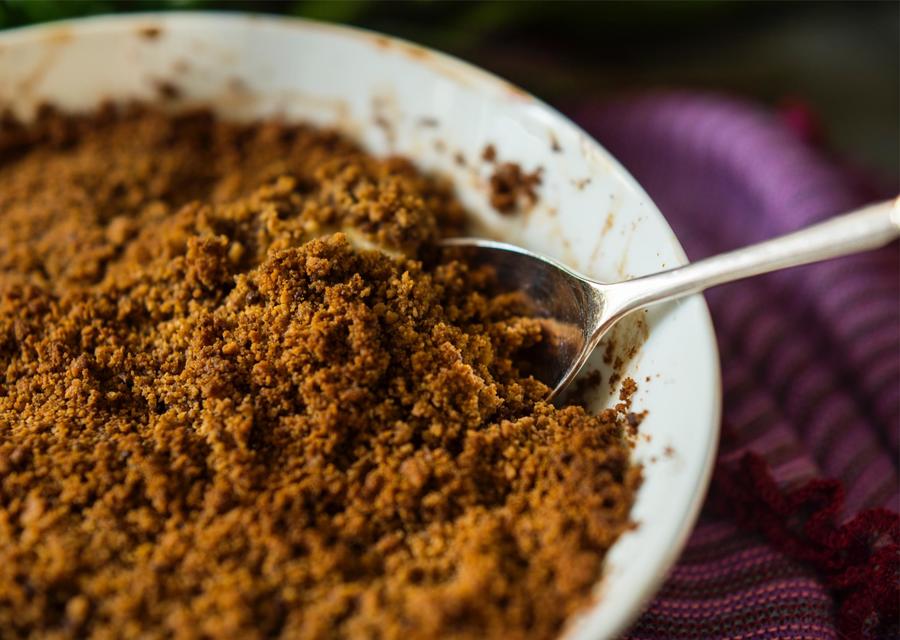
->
left=0, top=13, right=721, bottom=639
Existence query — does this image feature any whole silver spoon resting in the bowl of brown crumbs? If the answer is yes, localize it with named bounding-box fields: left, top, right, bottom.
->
left=441, top=198, right=900, bottom=399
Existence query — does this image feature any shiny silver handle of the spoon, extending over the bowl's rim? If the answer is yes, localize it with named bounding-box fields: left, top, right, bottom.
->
left=597, top=197, right=900, bottom=325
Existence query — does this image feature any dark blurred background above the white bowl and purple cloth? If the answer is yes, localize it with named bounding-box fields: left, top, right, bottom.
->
left=0, top=0, right=900, bottom=184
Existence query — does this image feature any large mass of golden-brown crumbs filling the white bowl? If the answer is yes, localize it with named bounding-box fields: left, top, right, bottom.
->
left=0, top=107, right=640, bottom=638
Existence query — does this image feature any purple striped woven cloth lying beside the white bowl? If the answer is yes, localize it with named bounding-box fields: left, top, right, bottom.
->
left=574, top=94, right=900, bottom=639
